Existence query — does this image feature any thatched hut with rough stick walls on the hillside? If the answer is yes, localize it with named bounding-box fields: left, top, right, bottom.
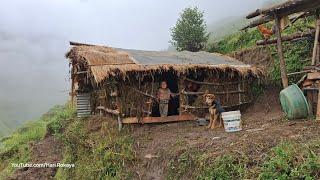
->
left=66, top=43, right=262, bottom=124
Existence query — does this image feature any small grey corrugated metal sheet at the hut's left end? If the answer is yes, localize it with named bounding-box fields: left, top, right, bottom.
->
left=77, top=93, right=91, bottom=117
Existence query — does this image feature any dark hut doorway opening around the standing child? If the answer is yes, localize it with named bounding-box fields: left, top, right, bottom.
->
left=151, top=71, right=180, bottom=117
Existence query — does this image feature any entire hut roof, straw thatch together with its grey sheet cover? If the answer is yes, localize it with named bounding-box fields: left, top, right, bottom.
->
left=66, top=44, right=262, bottom=83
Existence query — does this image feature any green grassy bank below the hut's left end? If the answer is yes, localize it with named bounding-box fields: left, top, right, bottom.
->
left=56, top=119, right=135, bottom=179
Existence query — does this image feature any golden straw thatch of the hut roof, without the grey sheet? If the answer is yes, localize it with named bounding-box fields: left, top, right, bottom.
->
left=66, top=46, right=263, bottom=84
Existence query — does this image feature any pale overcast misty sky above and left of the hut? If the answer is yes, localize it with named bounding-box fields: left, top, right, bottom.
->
left=0, top=0, right=274, bottom=130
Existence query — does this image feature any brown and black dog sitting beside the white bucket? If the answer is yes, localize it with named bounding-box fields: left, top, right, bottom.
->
left=203, top=92, right=223, bottom=129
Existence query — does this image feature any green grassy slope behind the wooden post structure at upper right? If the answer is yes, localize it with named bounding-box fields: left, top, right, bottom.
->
left=207, top=18, right=314, bottom=83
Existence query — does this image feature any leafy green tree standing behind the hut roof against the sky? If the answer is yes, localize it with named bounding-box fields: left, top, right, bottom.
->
left=170, top=7, right=209, bottom=52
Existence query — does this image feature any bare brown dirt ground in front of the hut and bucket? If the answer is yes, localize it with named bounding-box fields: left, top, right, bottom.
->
left=129, top=87, right=320, bottom=179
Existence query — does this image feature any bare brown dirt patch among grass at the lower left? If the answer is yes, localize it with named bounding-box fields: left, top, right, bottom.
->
left=10, top=136, right=63, bottom=180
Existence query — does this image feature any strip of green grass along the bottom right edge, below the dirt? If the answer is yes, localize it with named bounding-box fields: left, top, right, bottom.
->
left=167, top=139, right=320, bottom=180
